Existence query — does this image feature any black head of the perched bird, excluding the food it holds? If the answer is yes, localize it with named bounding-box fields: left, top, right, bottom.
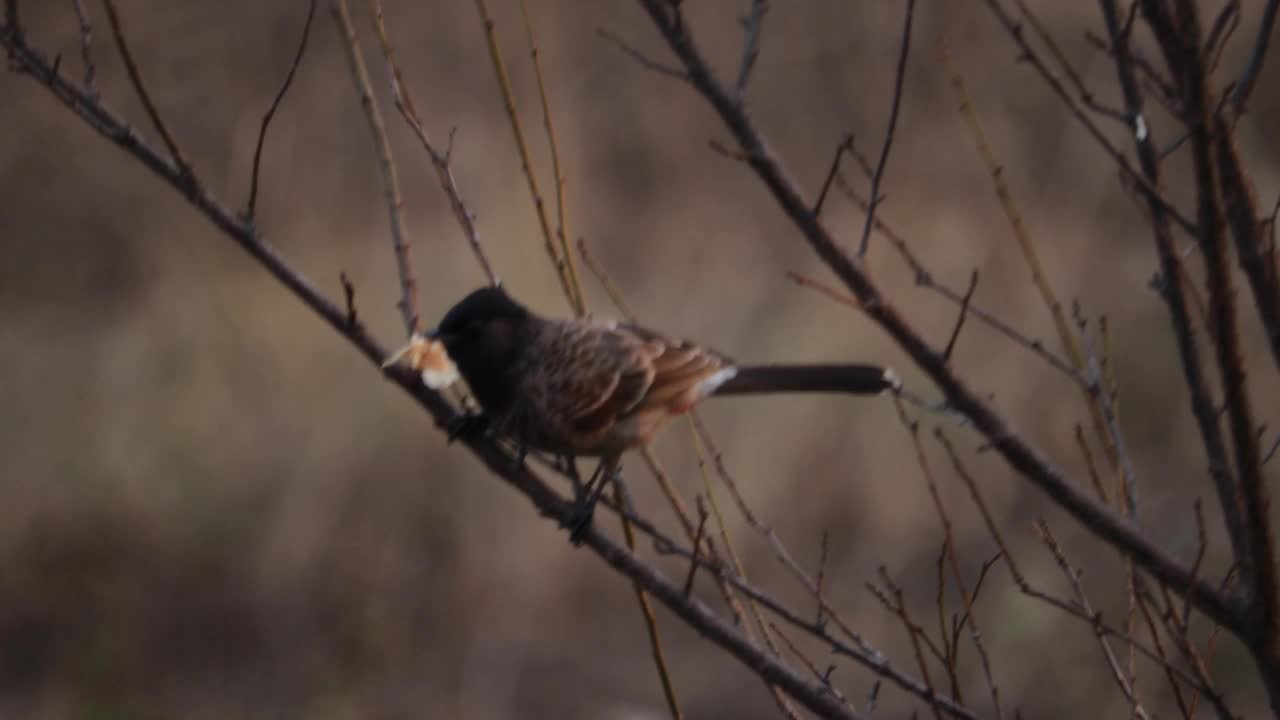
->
left=430, top=287, right=538, bottom=411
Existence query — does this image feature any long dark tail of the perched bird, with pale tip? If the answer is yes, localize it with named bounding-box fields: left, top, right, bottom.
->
left=712, top=365, right=902, bottom=395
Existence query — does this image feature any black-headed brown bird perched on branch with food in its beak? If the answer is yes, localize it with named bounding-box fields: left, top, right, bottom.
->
left=388, top=286, right=901, bottom=543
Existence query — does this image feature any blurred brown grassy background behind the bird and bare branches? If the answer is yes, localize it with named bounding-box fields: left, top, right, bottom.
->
left=0, top=0, right=1280, bottom=719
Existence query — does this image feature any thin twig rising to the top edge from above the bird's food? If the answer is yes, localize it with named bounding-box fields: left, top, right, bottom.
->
left=329, top=0, right=421, bottom=336
